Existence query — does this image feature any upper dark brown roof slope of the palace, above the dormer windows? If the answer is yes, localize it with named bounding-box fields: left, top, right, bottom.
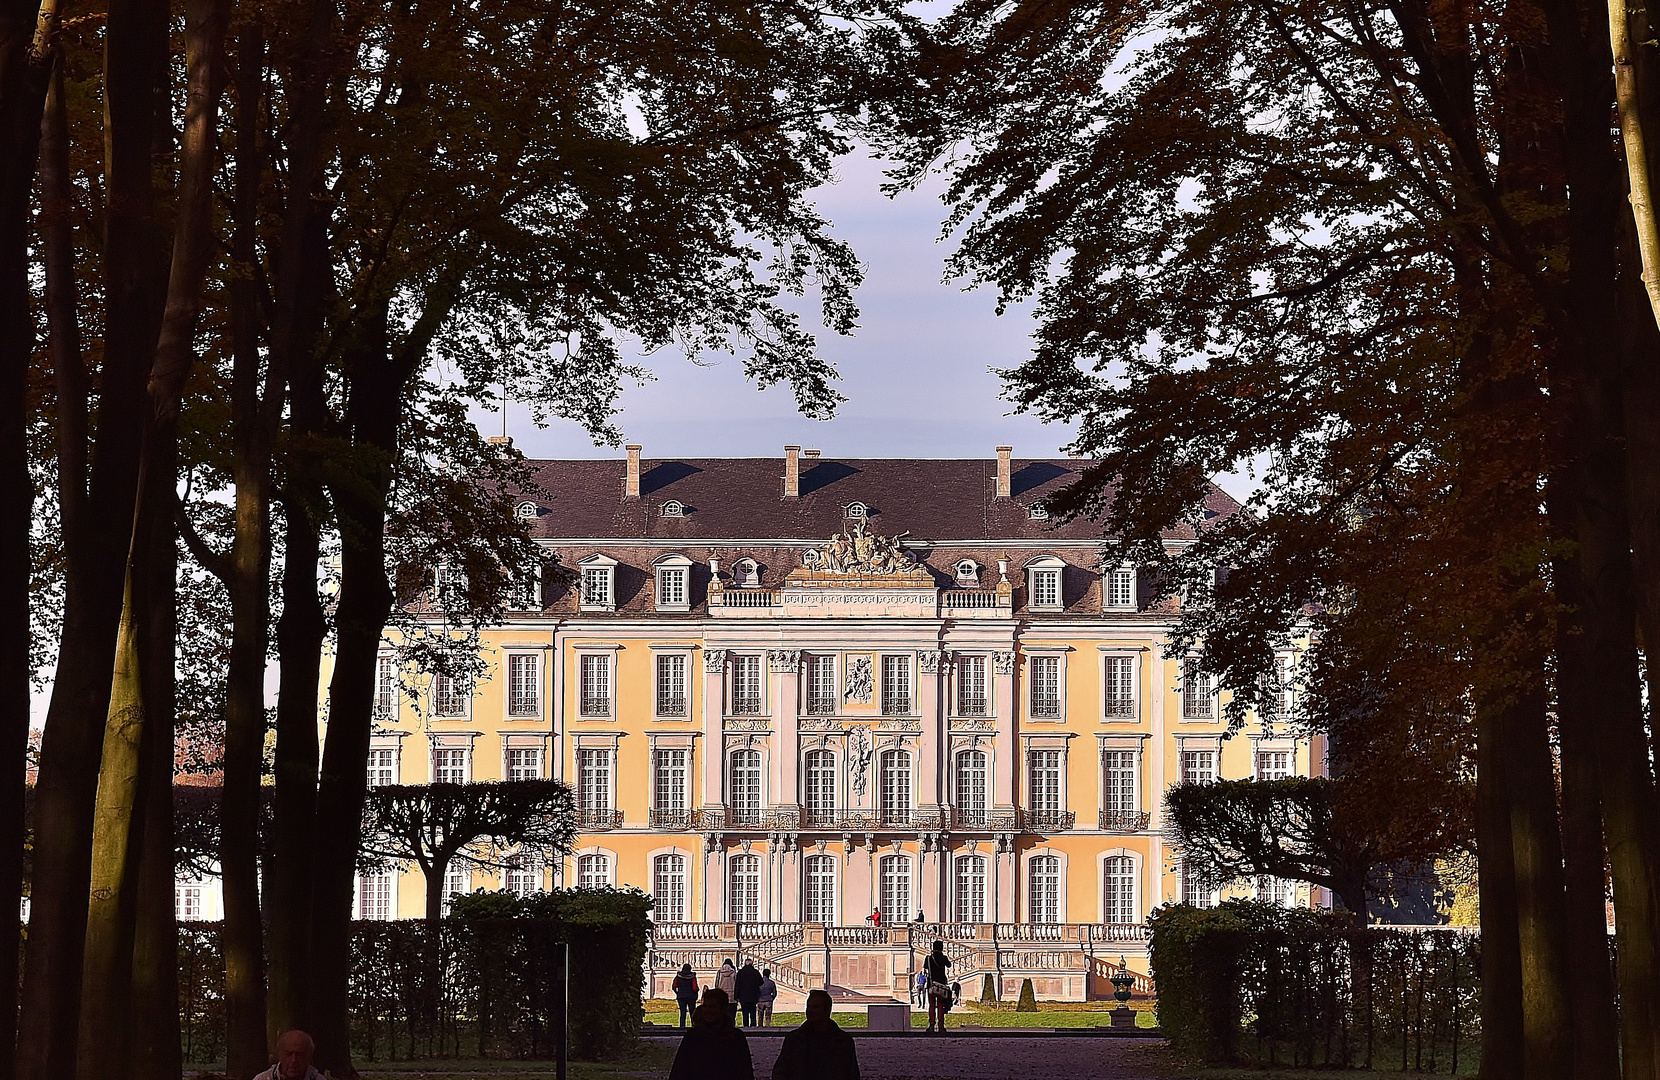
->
left=511, top=456, right=1240, bottom=544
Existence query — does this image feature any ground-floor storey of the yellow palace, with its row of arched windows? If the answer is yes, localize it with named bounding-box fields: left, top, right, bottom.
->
left=333, top=848, right=1306, bottom=926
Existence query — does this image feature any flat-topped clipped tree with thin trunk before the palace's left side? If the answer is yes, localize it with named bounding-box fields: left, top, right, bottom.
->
left=360, top=780, right=576, bottom=922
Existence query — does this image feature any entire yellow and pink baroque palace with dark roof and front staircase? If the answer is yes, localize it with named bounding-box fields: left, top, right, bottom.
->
left=343, top=446, right=1323, bottom=999
